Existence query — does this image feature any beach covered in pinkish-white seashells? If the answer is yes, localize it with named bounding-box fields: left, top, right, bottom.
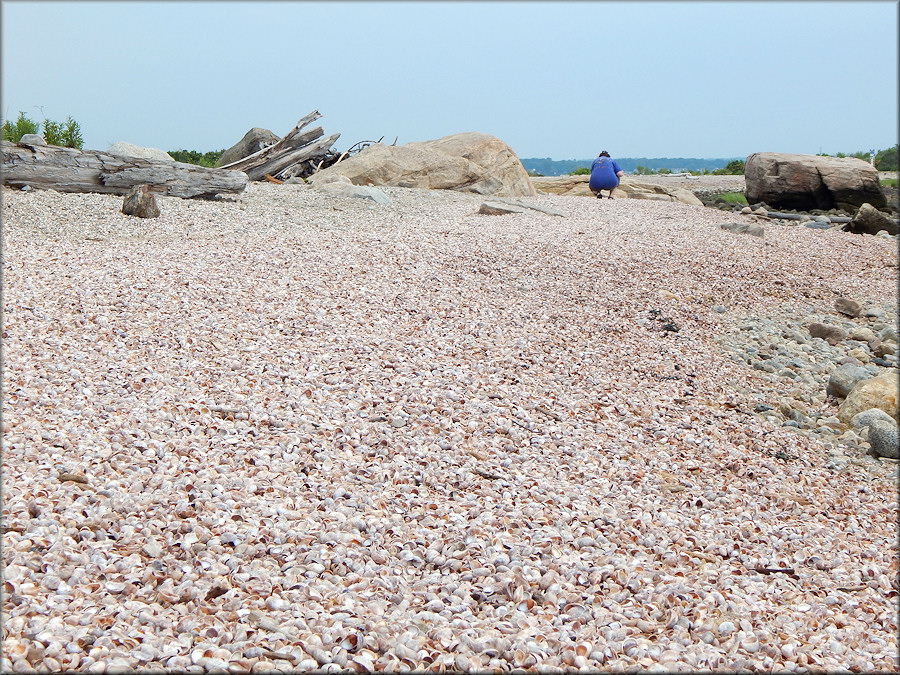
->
left=0, top=183, right=900, bottom=673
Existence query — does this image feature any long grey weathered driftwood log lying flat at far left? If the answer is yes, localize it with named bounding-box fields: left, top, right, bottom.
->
left=2, top=141, right=248, bottom=197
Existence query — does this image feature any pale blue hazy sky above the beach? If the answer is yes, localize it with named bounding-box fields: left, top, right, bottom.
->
left=0, top=0, right=898, bottom=159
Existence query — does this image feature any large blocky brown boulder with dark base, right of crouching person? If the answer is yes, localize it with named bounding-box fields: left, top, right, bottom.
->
left=744, top=152, right=887, bottom=211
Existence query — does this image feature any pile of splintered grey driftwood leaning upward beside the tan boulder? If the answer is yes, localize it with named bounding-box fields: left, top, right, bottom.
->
left=220, top=110, right=341, bottom=180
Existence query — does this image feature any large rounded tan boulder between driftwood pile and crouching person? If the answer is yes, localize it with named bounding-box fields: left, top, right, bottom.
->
left=309, top=132, right=537, bottom=197
